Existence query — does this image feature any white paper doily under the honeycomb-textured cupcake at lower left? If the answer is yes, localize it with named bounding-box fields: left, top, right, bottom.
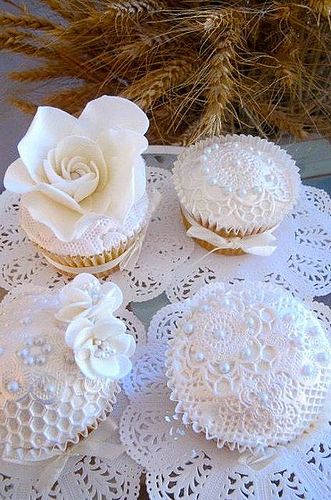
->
left=0, top=285, right=147, bottom=500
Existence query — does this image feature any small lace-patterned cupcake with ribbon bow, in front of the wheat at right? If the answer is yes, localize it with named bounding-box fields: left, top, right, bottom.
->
left=173, top=135, right=300, bottom=255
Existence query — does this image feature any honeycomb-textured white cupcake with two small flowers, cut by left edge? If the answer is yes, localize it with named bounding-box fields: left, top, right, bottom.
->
left=0, top=274, right=135, bottom=463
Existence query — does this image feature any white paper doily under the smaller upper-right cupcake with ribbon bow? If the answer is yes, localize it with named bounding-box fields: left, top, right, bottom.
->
left=166, top=186, right=331, bottom=302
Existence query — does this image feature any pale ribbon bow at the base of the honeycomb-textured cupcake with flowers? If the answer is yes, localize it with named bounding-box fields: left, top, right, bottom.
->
left=38, top=418, right=125, bottom=493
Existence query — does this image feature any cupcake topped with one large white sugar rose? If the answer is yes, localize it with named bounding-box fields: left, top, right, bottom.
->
left=4, top=96, right=150, bottom=274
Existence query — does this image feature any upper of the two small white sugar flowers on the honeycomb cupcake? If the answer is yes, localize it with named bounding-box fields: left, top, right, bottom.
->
left=55, top=273, right=123, bottom=323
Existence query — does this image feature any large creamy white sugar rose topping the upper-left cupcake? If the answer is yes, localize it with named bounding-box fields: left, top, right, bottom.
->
left=4, top=96, right=148, bottom=241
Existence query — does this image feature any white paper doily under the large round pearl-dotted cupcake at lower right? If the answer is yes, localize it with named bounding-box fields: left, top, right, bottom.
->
left=120, top=296, right=331, bottom=500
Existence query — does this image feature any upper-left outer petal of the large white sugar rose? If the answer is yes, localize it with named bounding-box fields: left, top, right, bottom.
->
left=17, top=106, right=77, bottom=182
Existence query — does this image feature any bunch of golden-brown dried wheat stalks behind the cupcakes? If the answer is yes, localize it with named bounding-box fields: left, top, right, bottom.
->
left=0, top=0, right=331, bottom=144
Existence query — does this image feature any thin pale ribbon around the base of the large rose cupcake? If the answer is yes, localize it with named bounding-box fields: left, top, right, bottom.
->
left=44, top=190, right=161, bottom=274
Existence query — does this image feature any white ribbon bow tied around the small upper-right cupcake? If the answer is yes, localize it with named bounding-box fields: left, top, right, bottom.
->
left=182, top=209, right=278, bottom=257
